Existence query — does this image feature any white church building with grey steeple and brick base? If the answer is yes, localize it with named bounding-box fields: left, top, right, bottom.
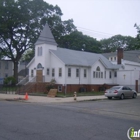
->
left=26, top=24, right=140, bottom=93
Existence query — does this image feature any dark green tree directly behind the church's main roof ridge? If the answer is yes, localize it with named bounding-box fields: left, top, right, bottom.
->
left=58, top=31, right=101, bottom=53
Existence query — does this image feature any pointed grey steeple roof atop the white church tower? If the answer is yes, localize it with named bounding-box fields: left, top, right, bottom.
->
left=35, top=23, right=57, bottom=45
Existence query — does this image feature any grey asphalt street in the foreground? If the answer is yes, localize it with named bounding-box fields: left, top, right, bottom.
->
left=0, top=97, right=140, bottom=140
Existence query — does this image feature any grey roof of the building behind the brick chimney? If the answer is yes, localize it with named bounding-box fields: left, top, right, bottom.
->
left=102, top=50, right=140, bottom=63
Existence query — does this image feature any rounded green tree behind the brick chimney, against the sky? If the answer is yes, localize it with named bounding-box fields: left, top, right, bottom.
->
left=100, top=35, right=136, bottom=52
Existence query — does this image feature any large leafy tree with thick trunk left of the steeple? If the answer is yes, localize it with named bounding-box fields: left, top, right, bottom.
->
left=0, top=0, right=76, bottom=82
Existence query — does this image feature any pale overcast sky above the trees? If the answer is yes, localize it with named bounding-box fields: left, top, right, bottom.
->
left=44, top=0, right=140, bottom=40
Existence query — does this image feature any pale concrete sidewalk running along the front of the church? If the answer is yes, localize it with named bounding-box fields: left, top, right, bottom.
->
left=0, top=93, right=140, bottom=103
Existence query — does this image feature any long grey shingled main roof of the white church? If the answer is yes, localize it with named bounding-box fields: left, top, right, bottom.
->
left=50, top=48, right=120, bottom=69
